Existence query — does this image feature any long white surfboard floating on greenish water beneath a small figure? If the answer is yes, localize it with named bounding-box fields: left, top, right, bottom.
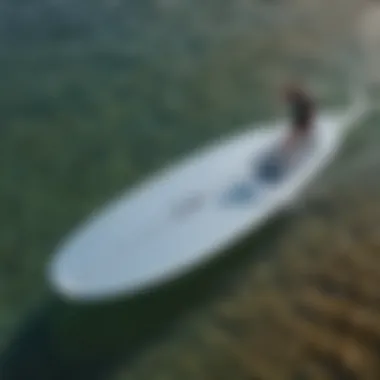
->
left=48, top=98, right=365, bottom=302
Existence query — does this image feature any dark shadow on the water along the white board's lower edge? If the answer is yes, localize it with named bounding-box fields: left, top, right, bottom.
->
left=0, top=214, right=289, bottom=380
